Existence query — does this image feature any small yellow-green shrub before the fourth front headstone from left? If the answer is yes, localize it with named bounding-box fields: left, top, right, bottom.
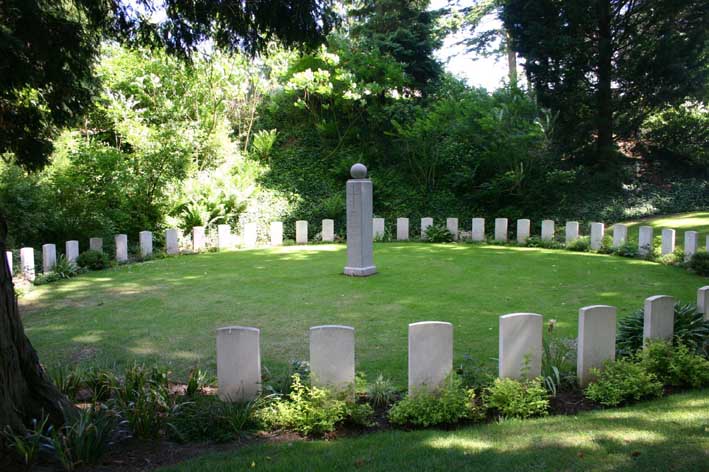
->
left=484, top=377, right=549, bottom=418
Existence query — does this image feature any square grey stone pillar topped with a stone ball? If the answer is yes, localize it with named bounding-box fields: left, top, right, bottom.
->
left=344, top=164, right=377, bottom=277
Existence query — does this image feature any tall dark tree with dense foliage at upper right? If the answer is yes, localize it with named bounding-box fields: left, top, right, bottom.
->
left=502, top=0, right=709, bottom=166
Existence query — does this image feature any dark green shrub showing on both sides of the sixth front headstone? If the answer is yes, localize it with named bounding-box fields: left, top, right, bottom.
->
left=615, top=303, right=709, bottom=357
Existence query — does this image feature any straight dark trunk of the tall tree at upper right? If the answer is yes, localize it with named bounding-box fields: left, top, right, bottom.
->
left=596, top=0, right=613, bottom=165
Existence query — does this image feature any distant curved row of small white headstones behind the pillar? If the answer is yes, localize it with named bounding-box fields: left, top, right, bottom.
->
left=7, top=218, right=709, bottom=280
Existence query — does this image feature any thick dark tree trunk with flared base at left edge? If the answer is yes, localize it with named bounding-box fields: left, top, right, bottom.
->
left=0, top=214, right=75, bottom=431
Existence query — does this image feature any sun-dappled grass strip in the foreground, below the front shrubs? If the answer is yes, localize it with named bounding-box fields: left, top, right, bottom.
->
left=161, top=390, right=709, bottom=472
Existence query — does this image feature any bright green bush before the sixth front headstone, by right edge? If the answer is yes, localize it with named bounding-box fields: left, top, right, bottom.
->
left=638, top=340, right=709, bottom=388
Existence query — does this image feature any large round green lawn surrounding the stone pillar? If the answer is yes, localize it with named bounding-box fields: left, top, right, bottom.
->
left=21, top=243, right=708, bottom=386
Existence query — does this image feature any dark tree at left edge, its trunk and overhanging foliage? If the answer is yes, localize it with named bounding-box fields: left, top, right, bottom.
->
left=0, top=0, right=335, bottom=430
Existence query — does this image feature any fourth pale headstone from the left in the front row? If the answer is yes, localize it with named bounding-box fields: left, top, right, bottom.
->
left=498, top=313, right=543, bottom=379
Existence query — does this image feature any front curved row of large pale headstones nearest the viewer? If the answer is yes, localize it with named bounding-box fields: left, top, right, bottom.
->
left=217, top=286, right=709, bottom=401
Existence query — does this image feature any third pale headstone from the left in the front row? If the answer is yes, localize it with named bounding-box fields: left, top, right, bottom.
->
left=409, top=321, right=453, bottom=395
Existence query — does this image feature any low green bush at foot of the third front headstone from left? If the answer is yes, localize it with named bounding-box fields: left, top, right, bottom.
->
left=389, top=373, right=479, bottom=427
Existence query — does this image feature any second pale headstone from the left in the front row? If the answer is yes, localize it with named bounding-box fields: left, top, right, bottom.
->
left=310, top=325, right=355, bottom=392
